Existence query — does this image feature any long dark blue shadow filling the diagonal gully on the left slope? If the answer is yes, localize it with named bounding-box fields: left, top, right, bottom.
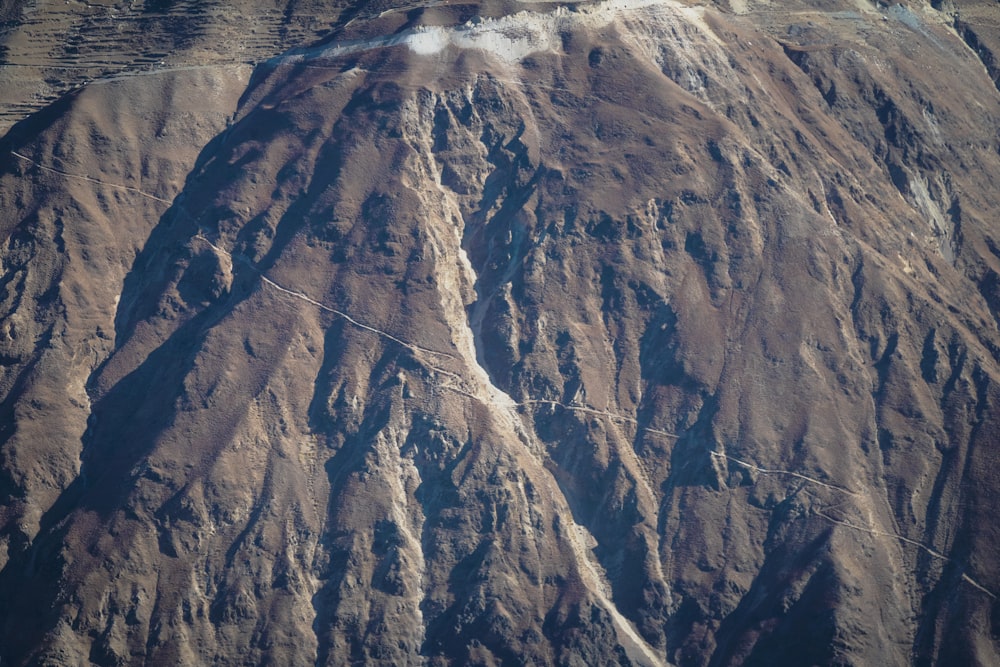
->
left=0, top=60, right=364, bottom=659
